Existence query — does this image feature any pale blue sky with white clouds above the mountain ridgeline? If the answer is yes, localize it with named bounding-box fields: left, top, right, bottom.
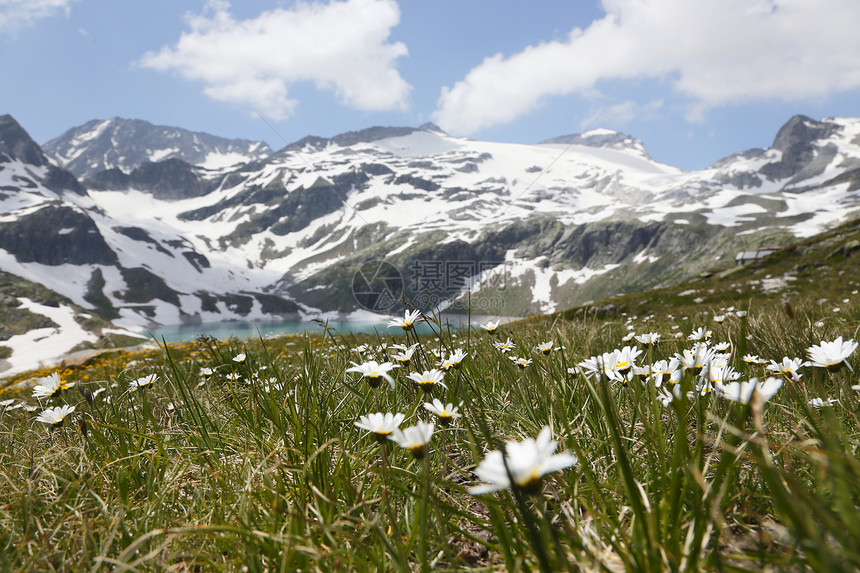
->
left=0, top=0, right=860, bottom=169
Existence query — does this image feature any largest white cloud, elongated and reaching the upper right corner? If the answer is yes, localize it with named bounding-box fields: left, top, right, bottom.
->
left=434, top=0, right=860, bottom=133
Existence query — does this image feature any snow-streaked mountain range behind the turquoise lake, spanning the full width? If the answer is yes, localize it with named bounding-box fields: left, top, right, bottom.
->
left=0, top=111, right=860, bottom=342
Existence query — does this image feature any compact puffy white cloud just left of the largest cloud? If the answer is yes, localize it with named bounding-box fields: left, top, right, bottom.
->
left=140, top=0, right=411, bottom=119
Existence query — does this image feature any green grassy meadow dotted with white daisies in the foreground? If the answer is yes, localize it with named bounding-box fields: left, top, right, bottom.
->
left=0, top=218, right=860, bottom=571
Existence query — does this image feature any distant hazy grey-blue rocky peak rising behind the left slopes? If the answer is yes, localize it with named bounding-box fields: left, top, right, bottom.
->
left=42, top=117, right=272, bottom=179
